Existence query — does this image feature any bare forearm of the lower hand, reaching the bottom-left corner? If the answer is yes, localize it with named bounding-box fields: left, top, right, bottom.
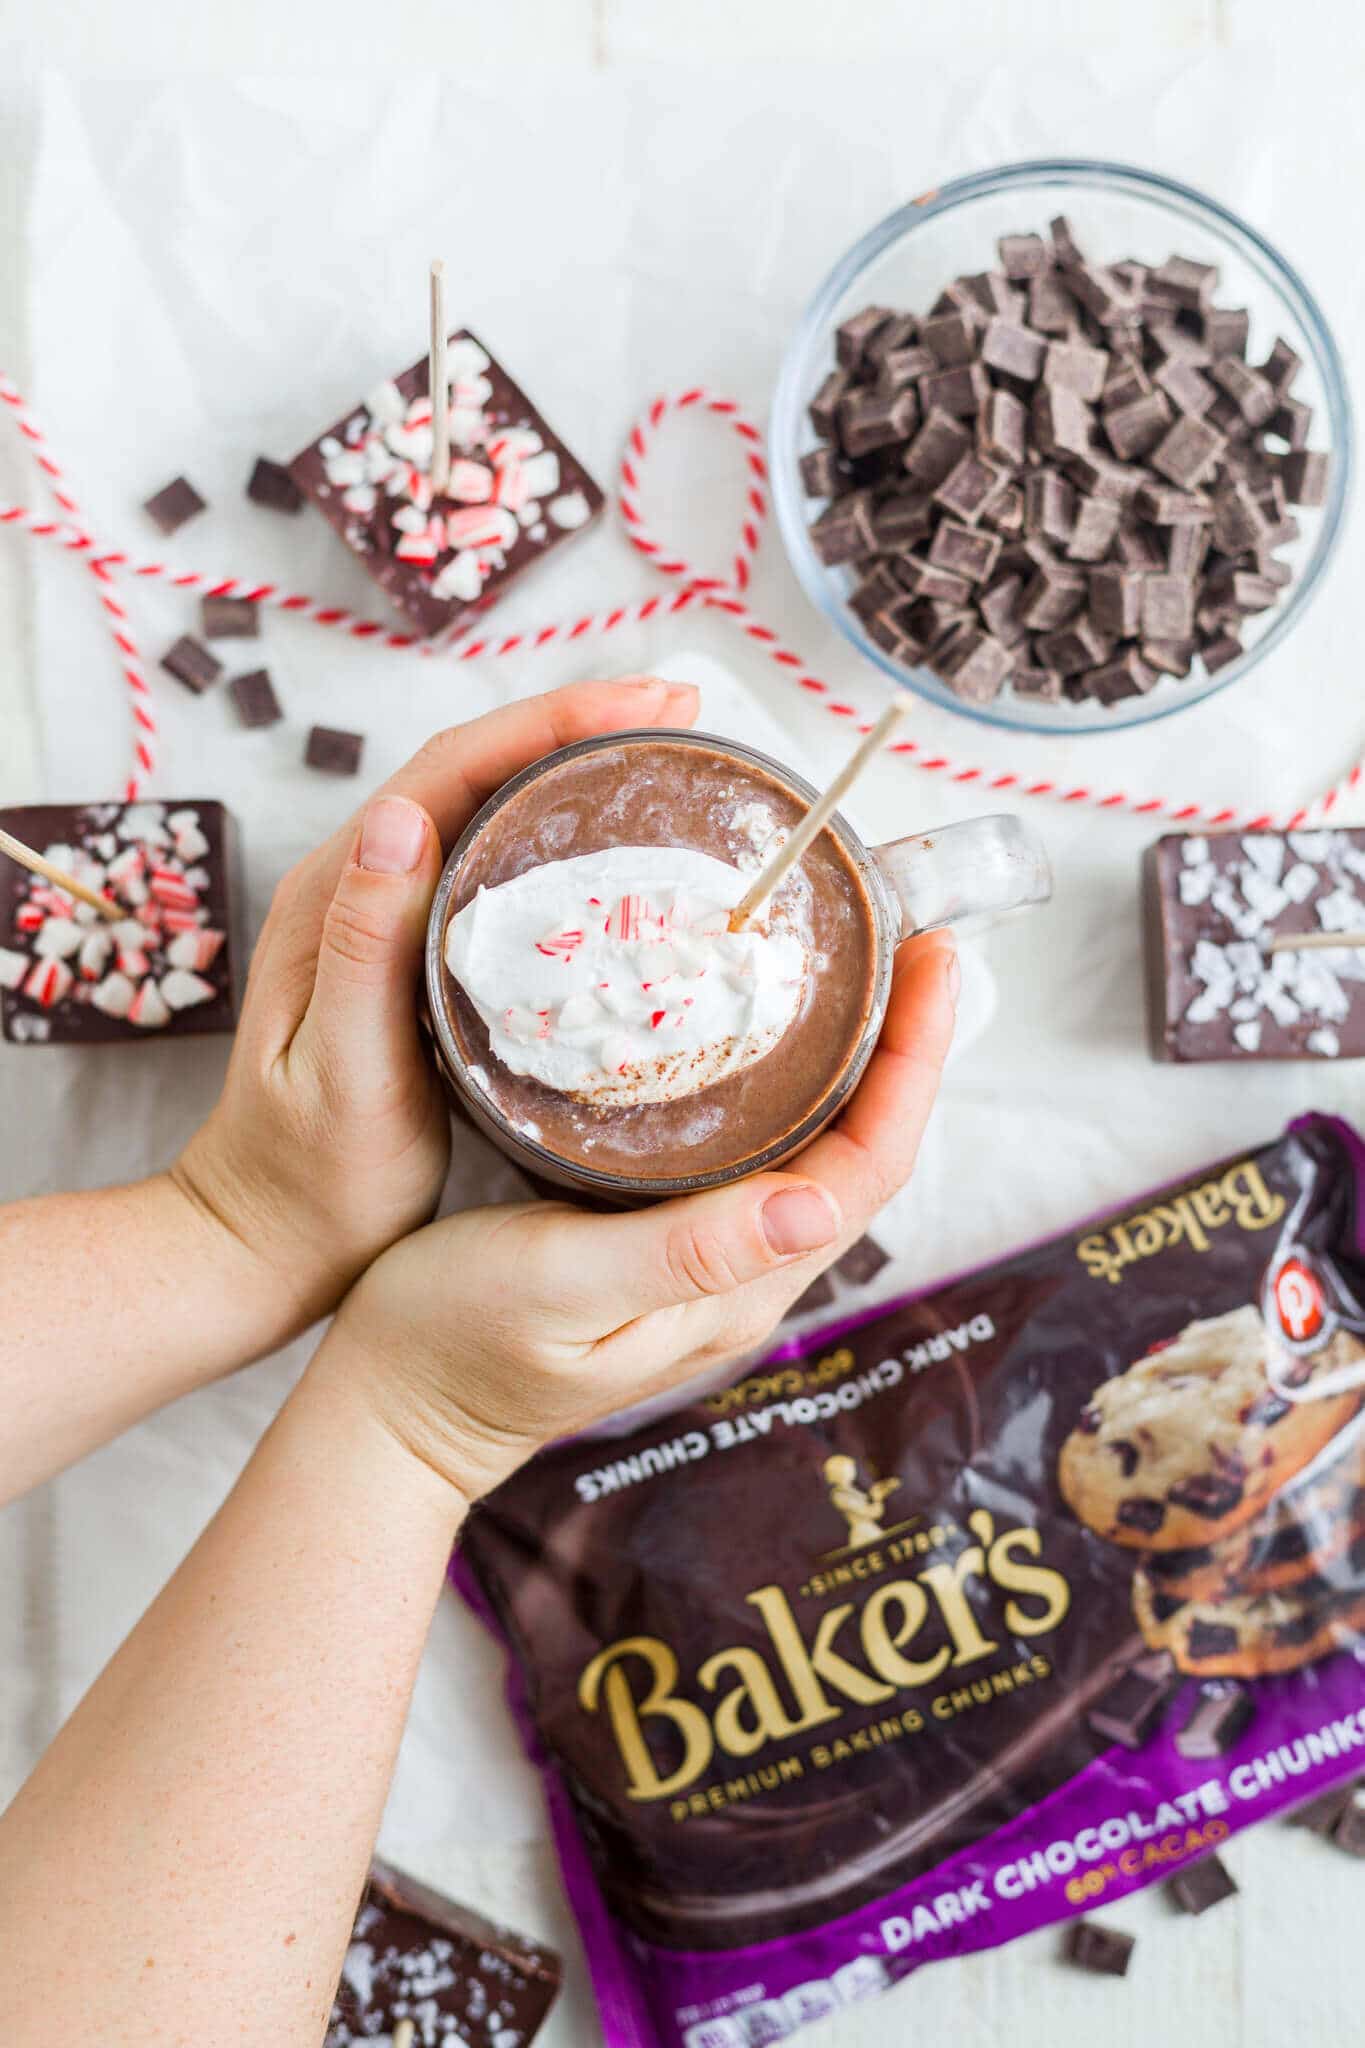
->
left=0, top=1333, right=463, bottom=2048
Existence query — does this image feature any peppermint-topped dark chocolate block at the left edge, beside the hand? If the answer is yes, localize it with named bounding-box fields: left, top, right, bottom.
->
left=0, top=797, right=241, bottom=1044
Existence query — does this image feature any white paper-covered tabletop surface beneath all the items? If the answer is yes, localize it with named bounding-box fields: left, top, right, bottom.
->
left=0, top=16, right=1365, bottom=2048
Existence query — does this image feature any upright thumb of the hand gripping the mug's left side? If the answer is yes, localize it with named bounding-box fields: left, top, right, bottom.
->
left=295, top=797, right=442, bottom=1087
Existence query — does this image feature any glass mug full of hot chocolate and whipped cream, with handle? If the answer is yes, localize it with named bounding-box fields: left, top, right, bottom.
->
left=426, top=729, right=1052, bottom=1204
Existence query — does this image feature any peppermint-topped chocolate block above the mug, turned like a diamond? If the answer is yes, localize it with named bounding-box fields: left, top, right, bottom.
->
left=289, top=330, right=604, bottom=637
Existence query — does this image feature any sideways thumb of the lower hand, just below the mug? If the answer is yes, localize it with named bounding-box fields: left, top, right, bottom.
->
left=557, top=1174, right=841, bottom=1337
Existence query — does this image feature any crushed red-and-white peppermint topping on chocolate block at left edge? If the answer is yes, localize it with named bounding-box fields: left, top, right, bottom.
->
left=0, top=803, right=227, bottom=1038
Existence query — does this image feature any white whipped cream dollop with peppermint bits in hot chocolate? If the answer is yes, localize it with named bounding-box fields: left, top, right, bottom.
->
left=446, top=846, right=810, bottom=1108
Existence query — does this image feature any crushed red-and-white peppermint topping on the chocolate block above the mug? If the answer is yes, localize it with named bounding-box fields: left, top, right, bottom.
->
left=317, top=334, right=596, bottom=604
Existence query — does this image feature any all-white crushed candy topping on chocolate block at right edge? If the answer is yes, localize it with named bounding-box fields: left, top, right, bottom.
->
left=1177, top=829, right=1365, bottom=1059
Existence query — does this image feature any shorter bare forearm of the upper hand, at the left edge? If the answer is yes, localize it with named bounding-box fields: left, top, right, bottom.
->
left=0, top=1174, right=313, bottom=1503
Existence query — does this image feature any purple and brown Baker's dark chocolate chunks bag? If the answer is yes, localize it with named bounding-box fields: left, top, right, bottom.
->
left=454, top=1116, right=1365, bottom=2048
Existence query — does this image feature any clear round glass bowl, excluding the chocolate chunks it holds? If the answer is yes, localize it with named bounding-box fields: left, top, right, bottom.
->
left=769, top=158, right=1351, bottom=735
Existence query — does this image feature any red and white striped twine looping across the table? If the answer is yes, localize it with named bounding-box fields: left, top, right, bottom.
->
left=0, top=373, right=1365, bottom=831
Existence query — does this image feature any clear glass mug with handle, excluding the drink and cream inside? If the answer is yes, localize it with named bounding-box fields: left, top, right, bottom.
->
left=426, top=727, right=1052, bottom=1206
